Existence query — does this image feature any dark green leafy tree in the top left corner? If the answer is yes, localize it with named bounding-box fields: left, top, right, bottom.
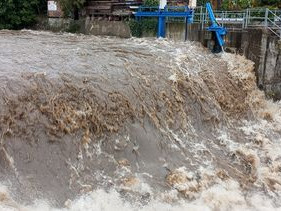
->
left=0, top=0, right=43, bottom=29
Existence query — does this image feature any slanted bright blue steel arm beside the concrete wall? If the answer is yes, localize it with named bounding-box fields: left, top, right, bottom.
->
left=206, top=3, right=227, bottom=47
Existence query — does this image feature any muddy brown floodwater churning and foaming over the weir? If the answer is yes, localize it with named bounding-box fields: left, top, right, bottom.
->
left=0, top=31, right=281, bottom=211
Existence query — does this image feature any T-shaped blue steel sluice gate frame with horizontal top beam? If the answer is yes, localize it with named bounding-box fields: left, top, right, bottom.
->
left=135, top=6, right=194, bottom=37
